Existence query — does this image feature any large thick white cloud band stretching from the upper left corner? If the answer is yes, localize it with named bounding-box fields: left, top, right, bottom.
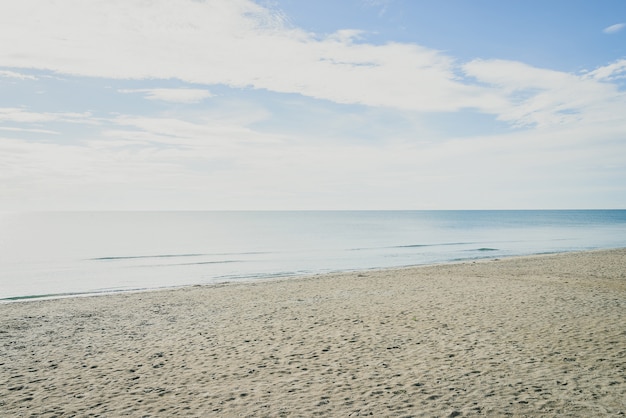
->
left=0, top=0, right=498, bottom=111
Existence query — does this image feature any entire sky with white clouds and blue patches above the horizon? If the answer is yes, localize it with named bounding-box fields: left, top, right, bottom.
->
left=0, top=0, right=626, bottom=211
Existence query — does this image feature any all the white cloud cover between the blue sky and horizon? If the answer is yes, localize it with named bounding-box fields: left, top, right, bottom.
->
left=0, top=0, right=626, bottom=209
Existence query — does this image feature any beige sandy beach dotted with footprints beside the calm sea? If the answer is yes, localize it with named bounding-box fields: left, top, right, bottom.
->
left=0, top=249, right=626, bottom=417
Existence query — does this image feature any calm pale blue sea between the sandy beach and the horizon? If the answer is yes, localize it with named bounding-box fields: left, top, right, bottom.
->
left=0, top=210, right=626, bottom=300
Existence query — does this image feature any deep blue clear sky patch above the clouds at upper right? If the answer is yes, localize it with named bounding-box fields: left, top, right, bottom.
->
left=280, top=0, right=626, bottom=71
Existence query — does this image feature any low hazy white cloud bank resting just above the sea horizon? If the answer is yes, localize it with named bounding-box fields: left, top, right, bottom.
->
left=0, top=108, right=626, bottom=209
